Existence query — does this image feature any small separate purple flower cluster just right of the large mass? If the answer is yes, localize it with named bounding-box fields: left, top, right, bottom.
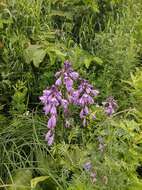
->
left=103, top=96, right=118, bottom=116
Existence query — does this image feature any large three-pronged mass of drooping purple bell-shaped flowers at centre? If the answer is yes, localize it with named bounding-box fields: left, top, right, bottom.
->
left=40, top=61, right=99, bottom=145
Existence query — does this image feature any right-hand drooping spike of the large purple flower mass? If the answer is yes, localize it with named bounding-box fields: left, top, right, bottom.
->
left=72, top=79, right=99, bottom=126
